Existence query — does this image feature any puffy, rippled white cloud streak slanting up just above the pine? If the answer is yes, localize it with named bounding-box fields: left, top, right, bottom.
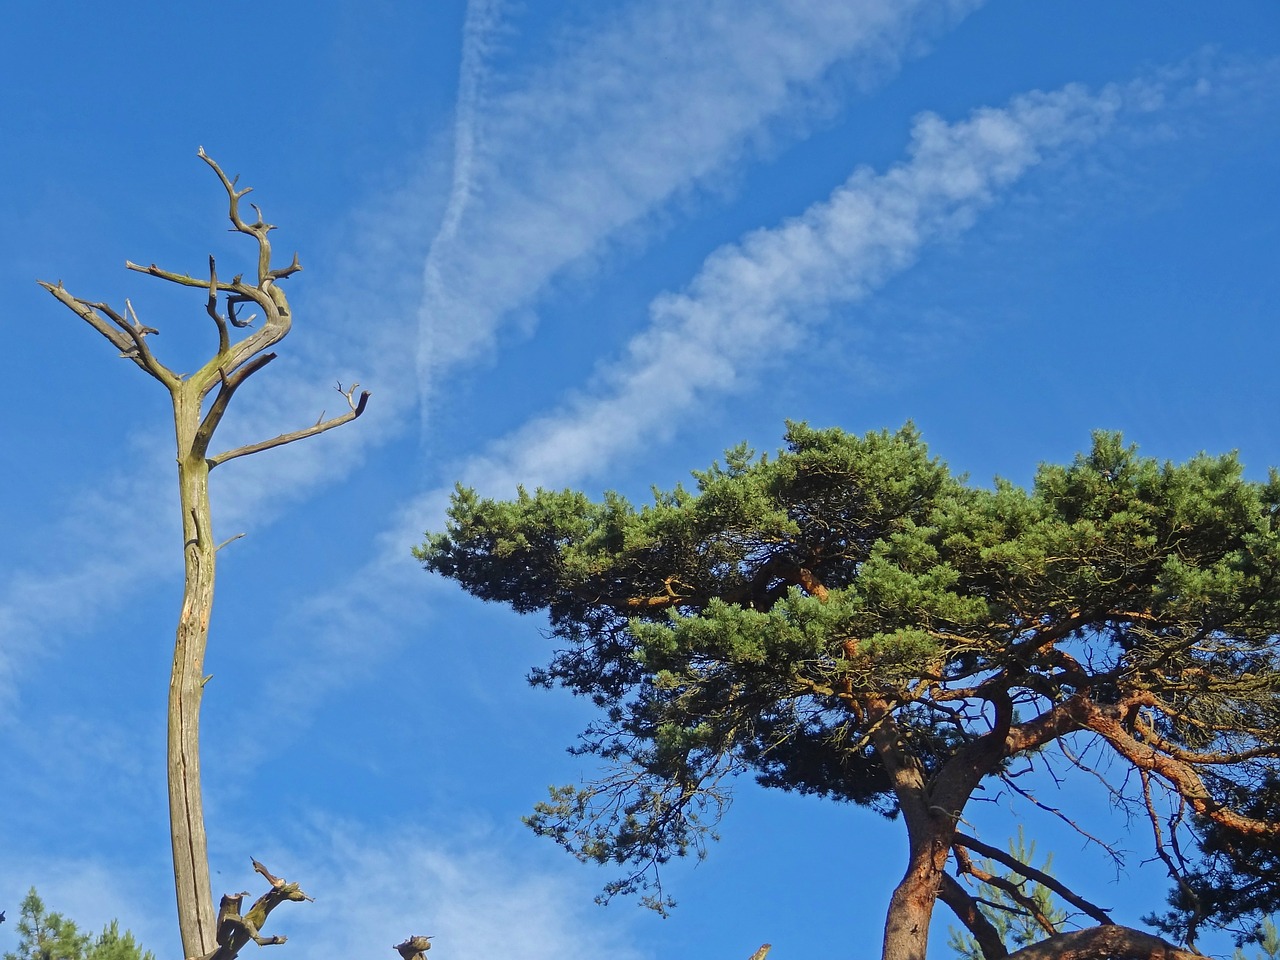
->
left=442, top=86, right=1131, bottom=496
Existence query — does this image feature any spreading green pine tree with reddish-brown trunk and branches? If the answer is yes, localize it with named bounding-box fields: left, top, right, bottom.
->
left=417, top=424, right=1280, bottom=957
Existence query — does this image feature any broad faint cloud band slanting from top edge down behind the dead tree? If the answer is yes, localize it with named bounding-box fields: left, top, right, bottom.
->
left=0, top=0, right=979, bottom=709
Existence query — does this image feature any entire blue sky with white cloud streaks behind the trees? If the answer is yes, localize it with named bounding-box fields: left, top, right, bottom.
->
left=0, top=0, right=1280, bottom=960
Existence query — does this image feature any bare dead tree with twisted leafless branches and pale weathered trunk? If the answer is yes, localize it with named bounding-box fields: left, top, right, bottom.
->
left=40, top=148, right=369, bottom=960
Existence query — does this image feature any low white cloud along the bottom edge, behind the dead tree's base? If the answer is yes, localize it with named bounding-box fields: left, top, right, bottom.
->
left=0, top=817, right=646, bottom=960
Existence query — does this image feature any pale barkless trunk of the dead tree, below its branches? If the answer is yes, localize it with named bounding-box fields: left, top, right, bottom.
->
left=169, top=396, right=218, bottom=957
